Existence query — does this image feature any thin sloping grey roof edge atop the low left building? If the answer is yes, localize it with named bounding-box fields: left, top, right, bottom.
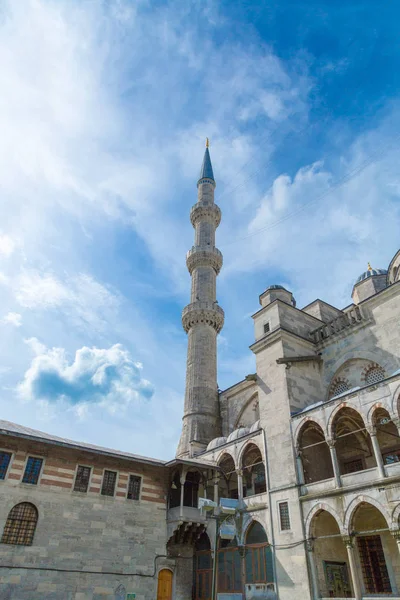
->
left=0, top=420, right=166, bottom=466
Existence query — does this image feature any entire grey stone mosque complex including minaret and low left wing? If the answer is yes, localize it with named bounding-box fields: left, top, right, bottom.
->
left=0, top=148, right=400, bottom=600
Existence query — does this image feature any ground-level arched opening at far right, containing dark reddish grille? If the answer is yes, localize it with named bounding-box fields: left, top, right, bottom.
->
left=350, top=502, right=400, bottom=594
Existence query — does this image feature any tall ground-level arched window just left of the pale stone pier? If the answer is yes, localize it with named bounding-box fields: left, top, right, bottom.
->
left=245, top=521, right=274, bottom=585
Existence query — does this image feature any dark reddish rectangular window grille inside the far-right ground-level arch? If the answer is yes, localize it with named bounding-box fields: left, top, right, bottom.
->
left=357, top=535, right=392, bottom=594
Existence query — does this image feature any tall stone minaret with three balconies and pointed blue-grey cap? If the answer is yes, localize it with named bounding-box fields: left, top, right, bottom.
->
left=176, top=139, right=224, bottom=457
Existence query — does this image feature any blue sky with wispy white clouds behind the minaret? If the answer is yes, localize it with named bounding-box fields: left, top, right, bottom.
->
left=0, top=0, right=400, bottom=458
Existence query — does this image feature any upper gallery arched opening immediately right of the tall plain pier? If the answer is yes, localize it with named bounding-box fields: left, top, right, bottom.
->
left=299, top=421, right=333, bottom=483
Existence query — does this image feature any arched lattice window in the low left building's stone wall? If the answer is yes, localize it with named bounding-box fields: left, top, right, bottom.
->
left=1, top=502, right=38, bottom=546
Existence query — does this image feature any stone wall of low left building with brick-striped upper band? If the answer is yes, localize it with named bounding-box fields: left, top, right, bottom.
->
left=0, top=436, right=173, bottom=600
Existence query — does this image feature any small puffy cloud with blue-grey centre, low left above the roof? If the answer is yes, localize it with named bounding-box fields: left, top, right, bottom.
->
left=17, top=339, right=153, bottom=417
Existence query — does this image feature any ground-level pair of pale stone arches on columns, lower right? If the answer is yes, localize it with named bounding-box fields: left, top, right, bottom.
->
left=306, top=496, right=400, bottom=600
